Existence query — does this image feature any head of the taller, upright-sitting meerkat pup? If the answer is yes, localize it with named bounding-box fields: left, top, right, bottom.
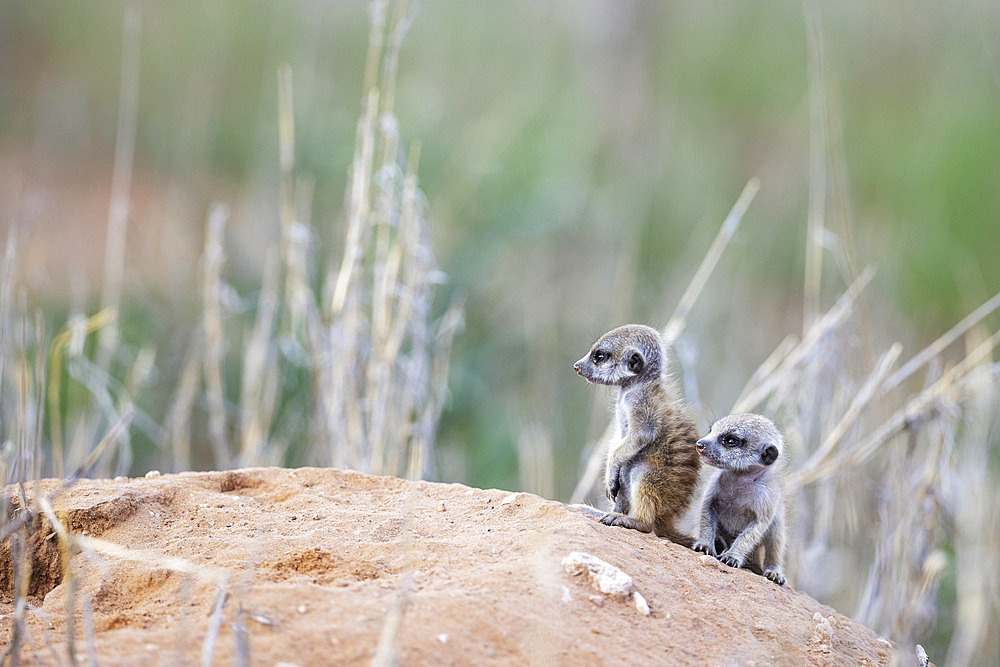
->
left=573, top=324, right=665, bottom=387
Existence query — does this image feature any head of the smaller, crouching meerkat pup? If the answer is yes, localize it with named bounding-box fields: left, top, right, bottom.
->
left=697, top=414, right=785, bottom=473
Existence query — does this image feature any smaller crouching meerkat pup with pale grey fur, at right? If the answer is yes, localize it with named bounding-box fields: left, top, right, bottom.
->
left=694, top=414, right=785, bottom=585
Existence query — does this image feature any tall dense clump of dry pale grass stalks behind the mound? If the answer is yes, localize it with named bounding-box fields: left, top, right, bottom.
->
left=286, top=3, right=461, bottom=476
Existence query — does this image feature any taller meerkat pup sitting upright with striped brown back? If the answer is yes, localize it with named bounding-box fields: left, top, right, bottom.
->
left=573, top=324, right=700, bottom=547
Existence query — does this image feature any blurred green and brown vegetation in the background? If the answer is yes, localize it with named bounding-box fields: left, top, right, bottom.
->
left=0, top=0, right=1000, bottom=657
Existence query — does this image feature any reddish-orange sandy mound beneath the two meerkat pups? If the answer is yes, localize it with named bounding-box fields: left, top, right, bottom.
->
left=0, top=468, right=892, bottom=665
